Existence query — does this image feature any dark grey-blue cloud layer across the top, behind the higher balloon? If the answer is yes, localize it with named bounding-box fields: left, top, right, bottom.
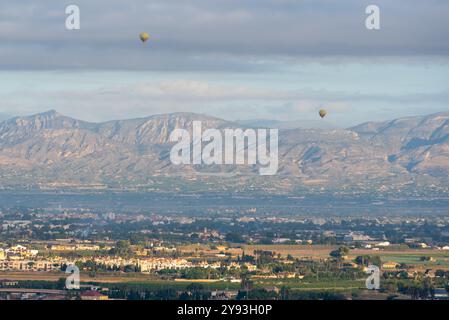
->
left=0, top=0, right=449, bottom=72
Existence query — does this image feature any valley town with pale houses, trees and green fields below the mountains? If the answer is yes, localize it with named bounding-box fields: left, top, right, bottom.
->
left=0, top=208, right=449, bottom=300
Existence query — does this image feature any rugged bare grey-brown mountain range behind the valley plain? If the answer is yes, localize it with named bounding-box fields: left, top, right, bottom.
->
left=0, top=110, right=449, bottom=194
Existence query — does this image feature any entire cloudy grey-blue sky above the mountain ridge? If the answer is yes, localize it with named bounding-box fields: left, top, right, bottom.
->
left=0, top=0, right=449, bottom=126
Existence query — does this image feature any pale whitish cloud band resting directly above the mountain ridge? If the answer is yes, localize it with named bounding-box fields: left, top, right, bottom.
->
left=2, top=77, right=449, bottom=125
